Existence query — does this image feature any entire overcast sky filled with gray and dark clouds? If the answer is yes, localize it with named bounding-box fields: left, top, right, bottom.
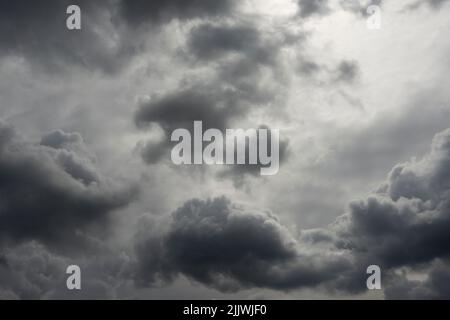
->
left=0, top=0, right=450, bottom=299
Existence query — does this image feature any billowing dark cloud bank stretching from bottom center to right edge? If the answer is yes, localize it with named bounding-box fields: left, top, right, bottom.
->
left=136, top=129, right=450, bottom=298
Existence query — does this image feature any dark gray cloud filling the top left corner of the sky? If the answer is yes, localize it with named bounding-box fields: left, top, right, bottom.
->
left=0, top=0, right=246, bottom=73
